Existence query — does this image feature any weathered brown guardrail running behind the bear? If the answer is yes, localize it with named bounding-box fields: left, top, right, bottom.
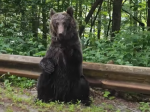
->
left=0, top=54, right=150, bottom=94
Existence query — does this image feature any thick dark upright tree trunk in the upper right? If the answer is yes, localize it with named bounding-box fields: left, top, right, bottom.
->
left=111, top=0, right=122, bottom=40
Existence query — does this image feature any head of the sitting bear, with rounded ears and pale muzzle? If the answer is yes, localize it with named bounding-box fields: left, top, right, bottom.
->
left=50, top=7, right=77, bottom=40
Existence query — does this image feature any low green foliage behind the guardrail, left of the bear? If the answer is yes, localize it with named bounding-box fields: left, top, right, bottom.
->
left=0, top=35, right=46, bottom=56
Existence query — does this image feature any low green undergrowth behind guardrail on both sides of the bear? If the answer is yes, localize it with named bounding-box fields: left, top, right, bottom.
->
left=0, top=30, right=150, bottom=67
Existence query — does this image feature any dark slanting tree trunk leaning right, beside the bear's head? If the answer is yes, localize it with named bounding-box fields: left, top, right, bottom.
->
left=79, top=0, right=103, bottom=38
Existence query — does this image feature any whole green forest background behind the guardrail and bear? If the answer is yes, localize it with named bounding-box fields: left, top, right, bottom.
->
left=0, top=0, right=150, bottom=67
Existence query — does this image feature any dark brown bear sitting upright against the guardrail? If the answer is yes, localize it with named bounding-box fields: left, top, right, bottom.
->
left=37, top=7, right=91, bottom=106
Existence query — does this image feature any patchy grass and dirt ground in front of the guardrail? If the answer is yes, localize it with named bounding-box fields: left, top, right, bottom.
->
left=0, top=82, right=150, bottom=112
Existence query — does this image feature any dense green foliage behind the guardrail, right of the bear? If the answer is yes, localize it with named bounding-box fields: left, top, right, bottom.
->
left=83, top=31, right=150, bottom=66
